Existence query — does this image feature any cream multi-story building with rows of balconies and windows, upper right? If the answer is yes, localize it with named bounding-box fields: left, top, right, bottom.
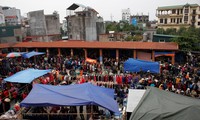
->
left=156, top=4, right=200, bottom=29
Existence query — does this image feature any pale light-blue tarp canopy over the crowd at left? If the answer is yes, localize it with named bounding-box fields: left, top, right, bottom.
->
left=4, top=68, right=51, bottom=83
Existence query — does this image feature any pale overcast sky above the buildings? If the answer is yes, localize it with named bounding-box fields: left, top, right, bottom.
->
left=0, top=0, right=200, bottom=21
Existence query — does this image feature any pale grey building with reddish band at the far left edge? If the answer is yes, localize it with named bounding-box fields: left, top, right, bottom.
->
left=2, top=7, right=21, bottom=25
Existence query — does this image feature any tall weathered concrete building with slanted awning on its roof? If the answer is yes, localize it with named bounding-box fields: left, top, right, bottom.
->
left=66, top=3, right=105, bottom=41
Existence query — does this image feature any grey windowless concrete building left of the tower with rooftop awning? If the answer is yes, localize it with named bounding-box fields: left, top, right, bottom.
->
left=25, top=10, right=60, bottom=42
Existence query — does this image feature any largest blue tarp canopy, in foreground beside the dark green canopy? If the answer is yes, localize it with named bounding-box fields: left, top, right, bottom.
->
left=20, top=83, right=119, bottom=115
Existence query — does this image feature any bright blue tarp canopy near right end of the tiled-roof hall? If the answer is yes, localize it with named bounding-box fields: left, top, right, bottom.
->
left=124, top=58, right=160, bottom=73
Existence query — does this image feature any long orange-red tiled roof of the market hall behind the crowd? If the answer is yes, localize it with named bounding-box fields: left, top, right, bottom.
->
left=12, top=40, right=178, bottom=50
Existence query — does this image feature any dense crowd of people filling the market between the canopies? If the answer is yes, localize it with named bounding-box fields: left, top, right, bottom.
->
left=0, top=52, right=200, bottom=120
